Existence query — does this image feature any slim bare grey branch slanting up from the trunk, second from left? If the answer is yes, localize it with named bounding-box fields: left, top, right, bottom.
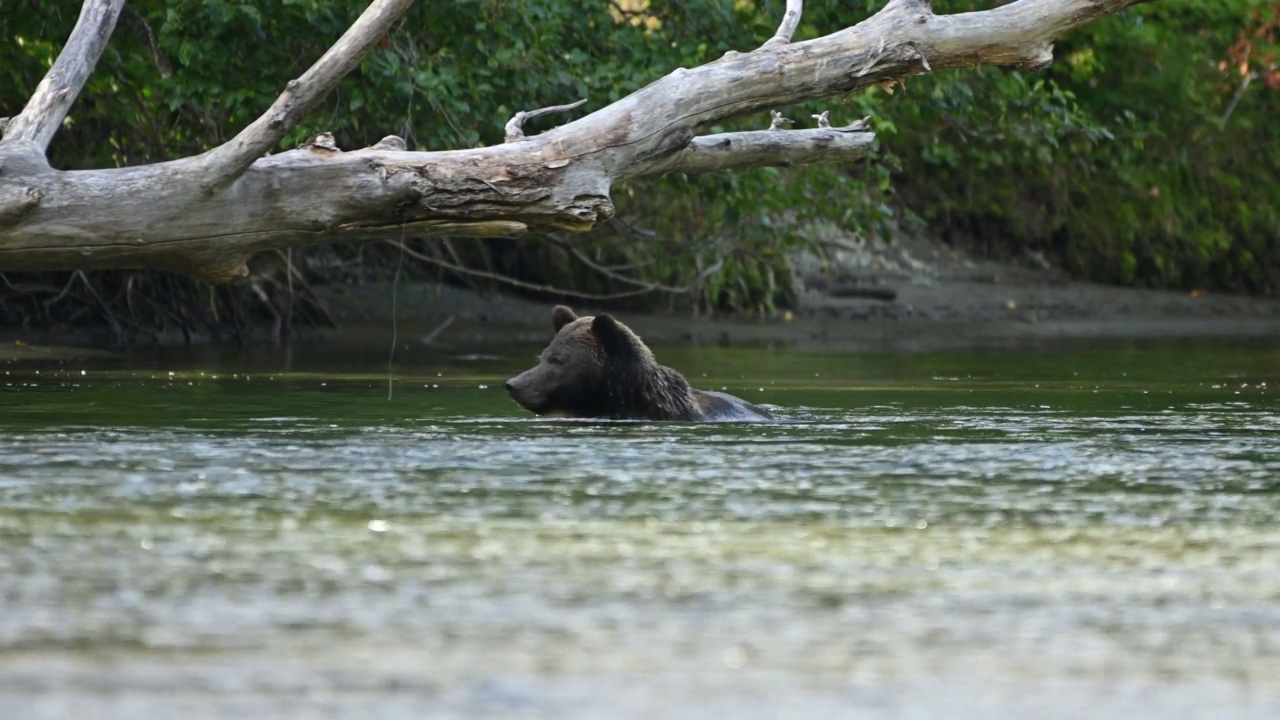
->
left=192, top=0, right=413, bottom=190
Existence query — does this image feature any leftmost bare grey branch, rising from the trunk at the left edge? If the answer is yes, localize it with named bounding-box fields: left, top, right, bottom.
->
left=0, top=0, right=124, bottom=152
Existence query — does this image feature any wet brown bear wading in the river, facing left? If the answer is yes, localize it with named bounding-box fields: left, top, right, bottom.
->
left=507, top=305, right=769, bottom=420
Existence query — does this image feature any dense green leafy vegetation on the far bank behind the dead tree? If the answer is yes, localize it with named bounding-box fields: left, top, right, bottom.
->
left=0, top=0, right=1280, bottom=320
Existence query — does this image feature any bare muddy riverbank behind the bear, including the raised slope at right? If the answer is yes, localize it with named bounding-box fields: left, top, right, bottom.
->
left=0, top=237, right=1280, bottom=360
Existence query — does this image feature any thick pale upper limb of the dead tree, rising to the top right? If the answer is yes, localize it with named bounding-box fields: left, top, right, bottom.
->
left=539, top=0, right=1137, bottom=179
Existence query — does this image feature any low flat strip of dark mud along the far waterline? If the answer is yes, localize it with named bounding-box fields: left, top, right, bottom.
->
left=10, top=274, right=1280, bottom=361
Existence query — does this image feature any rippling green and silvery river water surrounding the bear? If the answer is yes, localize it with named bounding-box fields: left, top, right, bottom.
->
left=0, top=333, right=1280, bottom=720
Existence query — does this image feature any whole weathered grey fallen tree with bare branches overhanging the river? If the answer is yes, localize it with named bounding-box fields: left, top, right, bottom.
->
left=0, top=0, right=1143, bottom=282
